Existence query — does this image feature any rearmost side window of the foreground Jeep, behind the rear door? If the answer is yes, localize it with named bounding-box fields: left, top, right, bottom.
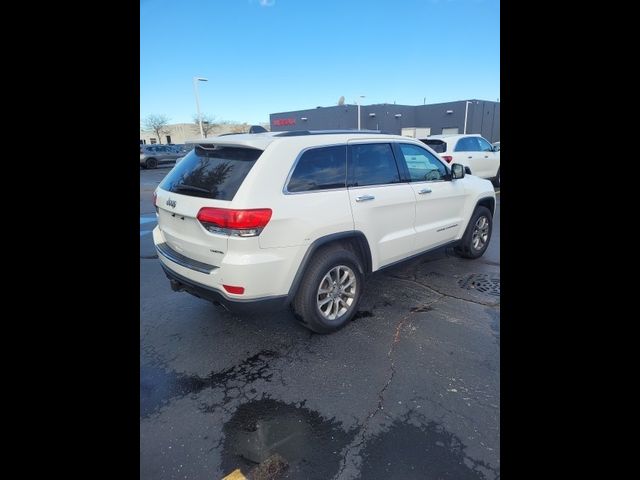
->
left=287, top=145, right=347, bottom=192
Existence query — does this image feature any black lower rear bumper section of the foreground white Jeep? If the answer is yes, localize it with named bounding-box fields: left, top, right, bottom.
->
left=160, top=262, right=288, bottom=313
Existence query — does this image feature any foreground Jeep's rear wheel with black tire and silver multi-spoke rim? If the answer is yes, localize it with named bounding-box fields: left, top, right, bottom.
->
left=292, top=246, right=364, bottom=333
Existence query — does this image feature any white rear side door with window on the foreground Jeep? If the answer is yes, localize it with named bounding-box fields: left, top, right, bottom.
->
left=347, top=140, right=416, bottom=270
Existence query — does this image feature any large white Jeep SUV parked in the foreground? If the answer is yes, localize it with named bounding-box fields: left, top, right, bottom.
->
left=153, top=131, right=495, bottom=333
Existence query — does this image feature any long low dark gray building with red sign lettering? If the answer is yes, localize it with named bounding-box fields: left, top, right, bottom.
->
left=270, top=100, right=500, bottom=142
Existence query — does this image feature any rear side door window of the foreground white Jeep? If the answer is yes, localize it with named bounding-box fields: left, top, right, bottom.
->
left=349, top=143, right=400, bottom=187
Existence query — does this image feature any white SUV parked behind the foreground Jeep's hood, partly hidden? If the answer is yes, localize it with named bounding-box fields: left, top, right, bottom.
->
left=422, top=133, right=500, bottom=187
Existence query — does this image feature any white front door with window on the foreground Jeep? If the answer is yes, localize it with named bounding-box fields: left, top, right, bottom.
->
left=396, top=143, right=465, bottom=251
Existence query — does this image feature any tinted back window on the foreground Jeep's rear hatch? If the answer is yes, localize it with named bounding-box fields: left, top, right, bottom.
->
left=160, top=145, right=263, bottom=200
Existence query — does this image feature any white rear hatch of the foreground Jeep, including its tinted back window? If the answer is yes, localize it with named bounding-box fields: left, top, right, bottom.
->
left=156, top=145, right=263, bottom=266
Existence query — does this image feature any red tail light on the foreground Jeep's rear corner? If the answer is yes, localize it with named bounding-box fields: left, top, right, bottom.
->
left=197, top=207, right=272, bottom=237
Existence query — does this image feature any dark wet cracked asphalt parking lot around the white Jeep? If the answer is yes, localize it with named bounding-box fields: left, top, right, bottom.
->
left=140, top=168, right=500, bottom=480
